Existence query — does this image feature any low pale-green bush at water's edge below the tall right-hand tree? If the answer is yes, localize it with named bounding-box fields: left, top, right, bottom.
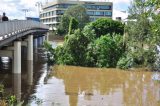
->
left=117, top=50, right=156, bottom=69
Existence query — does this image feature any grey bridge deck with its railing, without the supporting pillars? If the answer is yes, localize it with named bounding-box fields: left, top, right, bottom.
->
left=0, top=20, right=49, bottom=47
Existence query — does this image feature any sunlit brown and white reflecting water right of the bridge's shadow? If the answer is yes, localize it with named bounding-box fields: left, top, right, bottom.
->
left=31, top=66, right=160, bottom=106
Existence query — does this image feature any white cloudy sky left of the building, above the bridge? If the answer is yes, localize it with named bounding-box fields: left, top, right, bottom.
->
left=0, top=0, right=42, bottom=19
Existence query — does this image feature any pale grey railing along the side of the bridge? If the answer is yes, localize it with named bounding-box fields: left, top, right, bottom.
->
left=0, top=20, right=49, bottom=40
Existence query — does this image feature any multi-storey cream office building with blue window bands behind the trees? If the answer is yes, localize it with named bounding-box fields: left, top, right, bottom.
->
left=40, top=0, right=113, bottom=30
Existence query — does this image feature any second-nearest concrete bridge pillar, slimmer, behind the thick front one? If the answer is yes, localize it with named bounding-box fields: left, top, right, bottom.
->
left=27, top=35, right=33, bottom=61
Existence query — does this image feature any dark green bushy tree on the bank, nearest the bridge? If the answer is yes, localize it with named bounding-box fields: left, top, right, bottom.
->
left=55, top=29, right=90, bottom=66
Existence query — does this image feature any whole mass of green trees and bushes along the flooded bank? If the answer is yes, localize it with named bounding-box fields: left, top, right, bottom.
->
left=45, top=0, right=160, bottom=69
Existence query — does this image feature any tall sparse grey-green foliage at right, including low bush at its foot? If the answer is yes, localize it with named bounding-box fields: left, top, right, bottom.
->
left=117, top=0, right=160, bottom=68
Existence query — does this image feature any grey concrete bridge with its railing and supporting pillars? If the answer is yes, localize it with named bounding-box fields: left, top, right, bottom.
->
left=0, top=20, right=49, bottom=74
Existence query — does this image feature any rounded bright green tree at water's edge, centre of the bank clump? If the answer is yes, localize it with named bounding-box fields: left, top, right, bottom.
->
left=86, top=34, right=124, bottom=67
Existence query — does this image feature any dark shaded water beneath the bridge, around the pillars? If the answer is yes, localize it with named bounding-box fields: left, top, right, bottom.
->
left=0, top=47, right=47, bottom=106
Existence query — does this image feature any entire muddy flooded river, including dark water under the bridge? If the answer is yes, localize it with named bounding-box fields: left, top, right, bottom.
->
left=0, top=41, right=160, bottom=106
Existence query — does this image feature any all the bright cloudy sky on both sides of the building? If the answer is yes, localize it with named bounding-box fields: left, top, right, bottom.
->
left=0, top=0, right=131, bottom=19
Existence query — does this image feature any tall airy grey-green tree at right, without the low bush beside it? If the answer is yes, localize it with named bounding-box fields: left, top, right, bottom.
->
left=124, top=0, right=156, bottom=67
